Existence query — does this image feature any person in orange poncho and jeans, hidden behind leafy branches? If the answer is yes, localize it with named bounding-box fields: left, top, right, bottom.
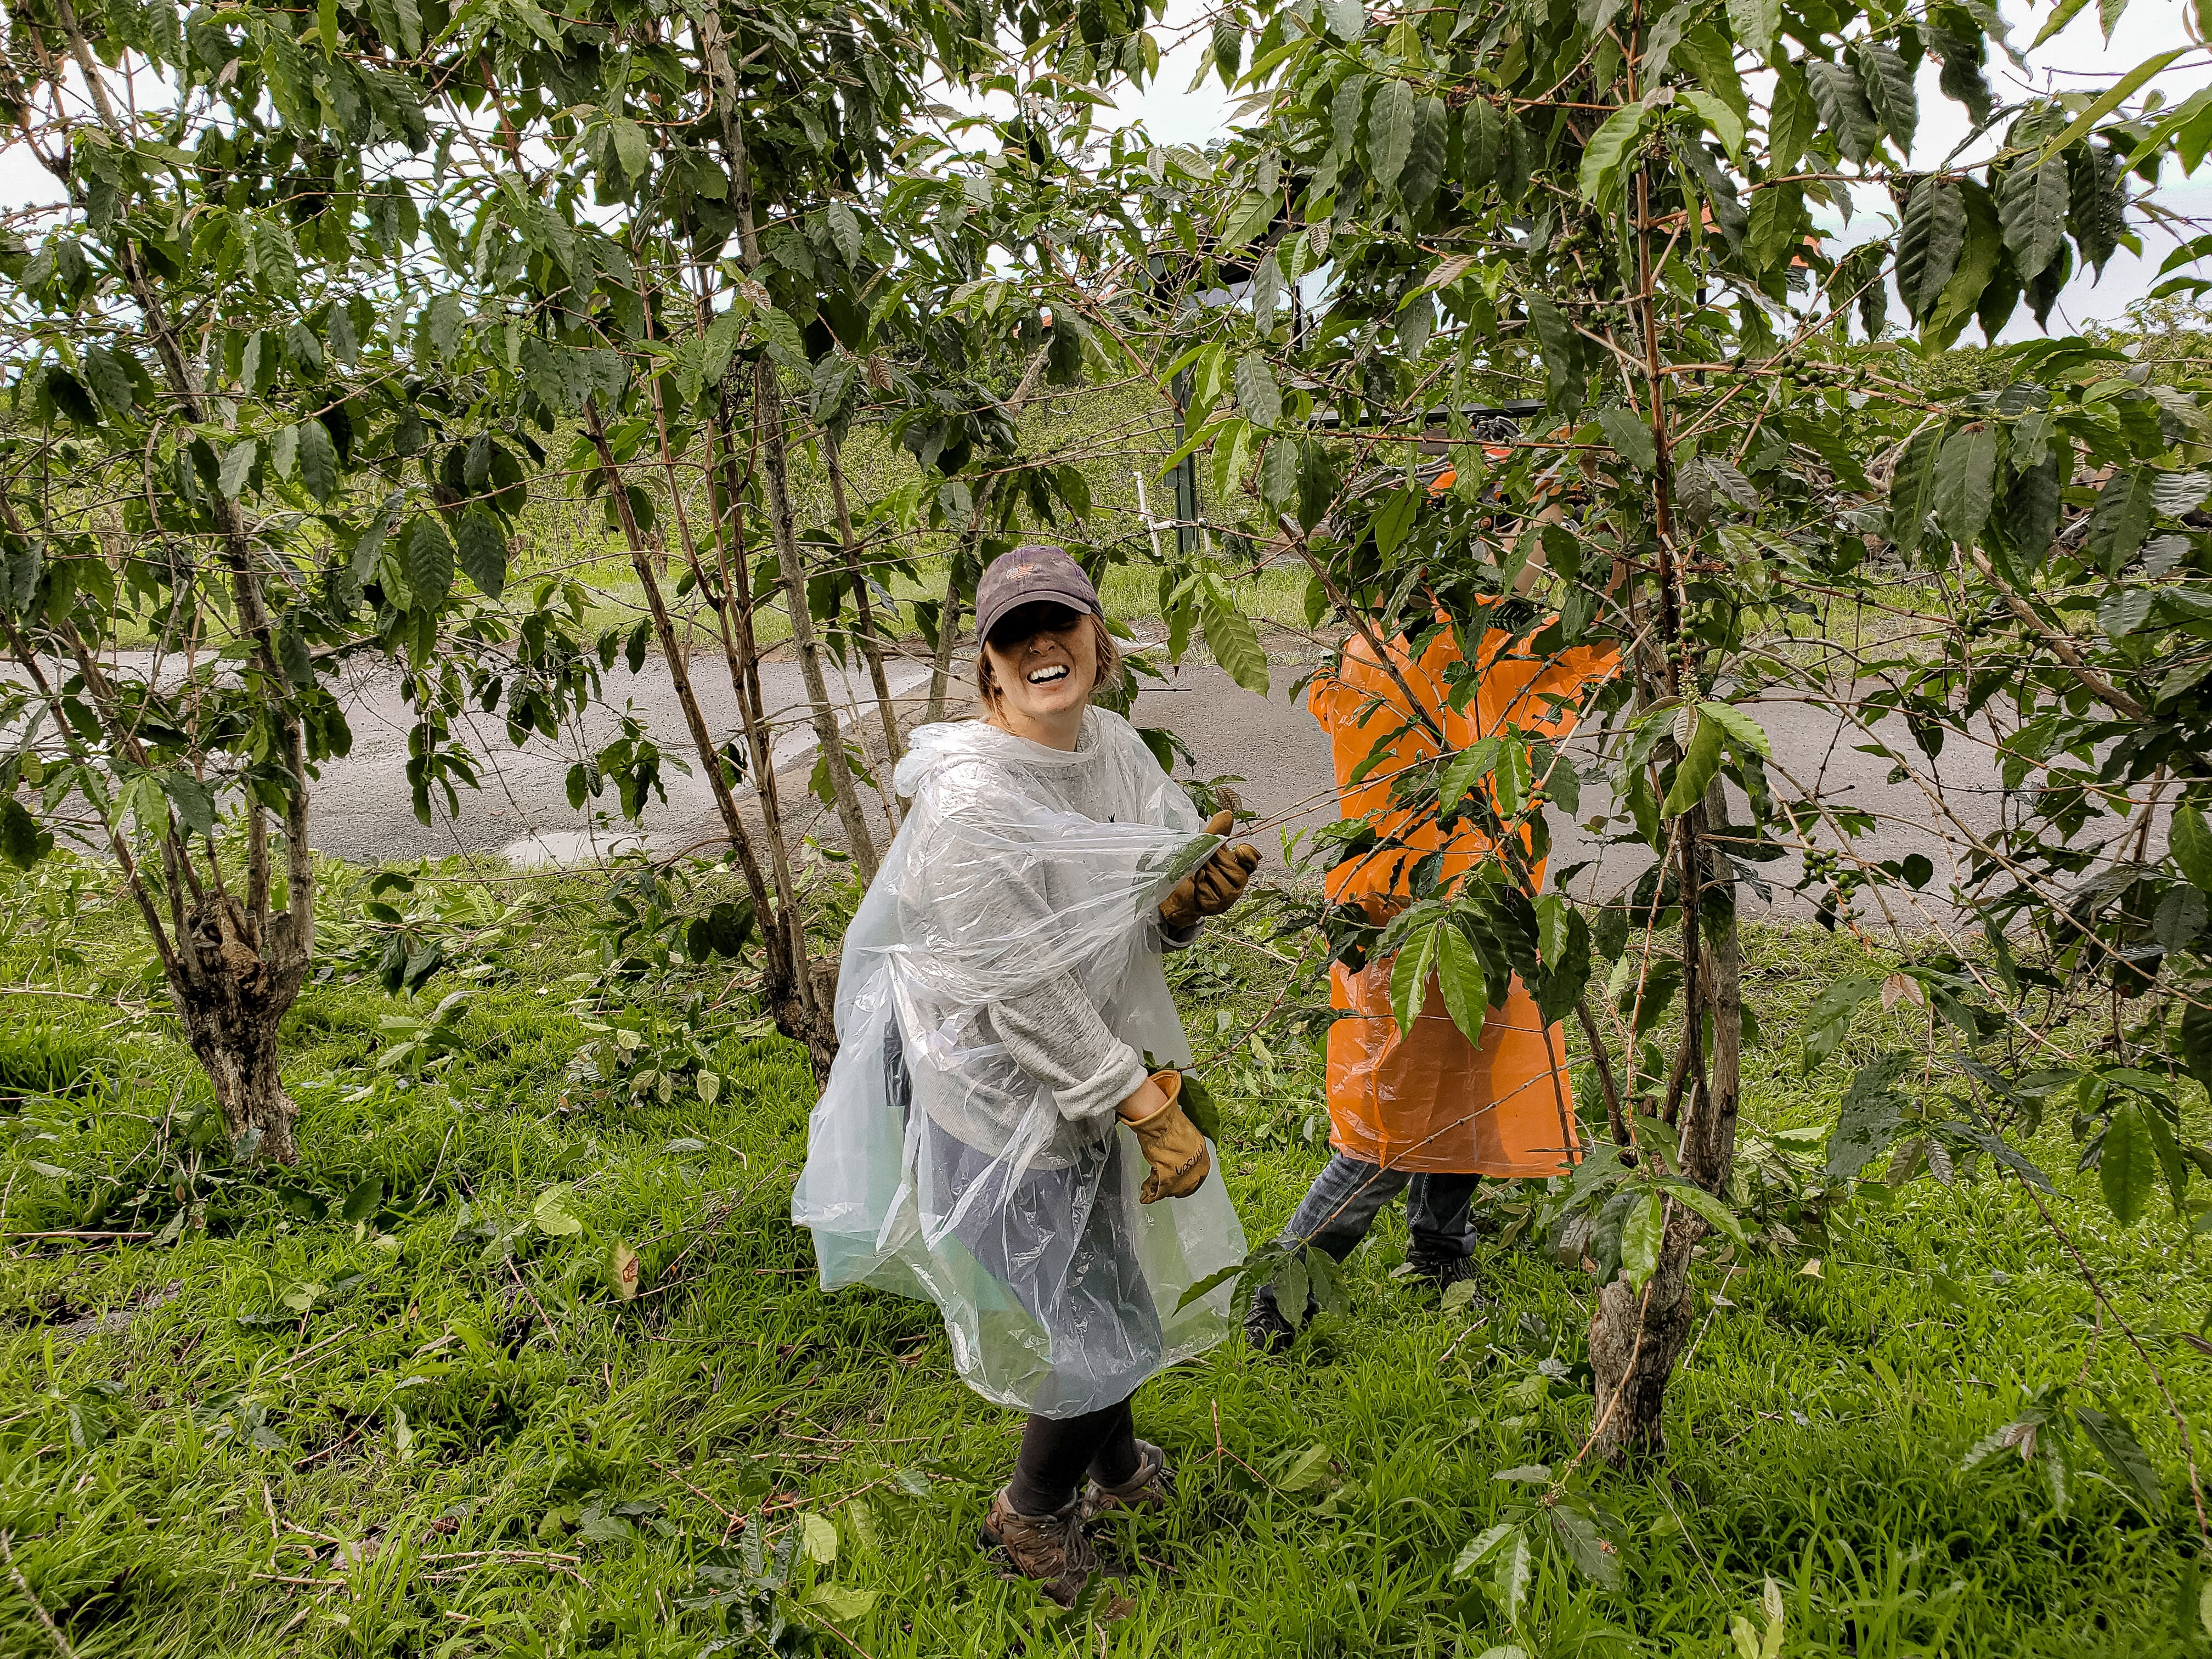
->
left=1245, top=473, right=1612, bottom=1352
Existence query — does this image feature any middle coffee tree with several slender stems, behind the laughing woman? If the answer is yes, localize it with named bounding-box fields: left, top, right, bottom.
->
left=393, top=4, right=1194, bottom=1068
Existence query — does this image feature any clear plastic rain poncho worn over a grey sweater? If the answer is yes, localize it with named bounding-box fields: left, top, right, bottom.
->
left=792, top=708, right=1245, bottom=1418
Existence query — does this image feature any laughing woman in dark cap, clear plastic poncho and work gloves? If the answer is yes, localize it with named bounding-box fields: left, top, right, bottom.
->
left=792, top=546, right=1259, bottom=1601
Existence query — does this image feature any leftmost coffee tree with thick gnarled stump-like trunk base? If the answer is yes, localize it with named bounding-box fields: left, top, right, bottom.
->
left=0, top=0, right=591, bottom=1161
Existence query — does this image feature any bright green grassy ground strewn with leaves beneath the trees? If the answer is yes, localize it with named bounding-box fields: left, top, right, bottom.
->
left=0, top=865, right=2212, bottom=1659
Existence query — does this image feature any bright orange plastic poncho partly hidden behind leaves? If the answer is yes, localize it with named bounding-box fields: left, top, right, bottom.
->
left=1305, top=628, right=1612, bottom=1177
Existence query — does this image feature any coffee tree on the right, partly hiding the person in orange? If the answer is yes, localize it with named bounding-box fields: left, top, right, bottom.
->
left=1183, top=0, right=2212, bottom=1495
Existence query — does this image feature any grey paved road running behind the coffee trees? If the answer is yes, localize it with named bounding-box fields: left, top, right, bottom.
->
left=30, top=637, right=2035, bottom=922
